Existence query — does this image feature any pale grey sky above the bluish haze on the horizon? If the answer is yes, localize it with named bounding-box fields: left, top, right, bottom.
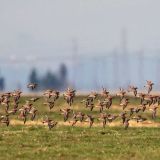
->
left=0, top=0, right=160, bottom=59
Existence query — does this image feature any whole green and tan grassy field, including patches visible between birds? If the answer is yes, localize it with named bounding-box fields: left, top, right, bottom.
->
left=0, top=97, right=160, bottom=160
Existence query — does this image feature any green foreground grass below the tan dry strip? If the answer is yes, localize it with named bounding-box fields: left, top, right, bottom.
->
left=0, top=126, right=160, bottom=160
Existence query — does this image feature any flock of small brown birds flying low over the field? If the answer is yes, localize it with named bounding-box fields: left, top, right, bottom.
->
left=0, top=81, right=160, bottom=129
